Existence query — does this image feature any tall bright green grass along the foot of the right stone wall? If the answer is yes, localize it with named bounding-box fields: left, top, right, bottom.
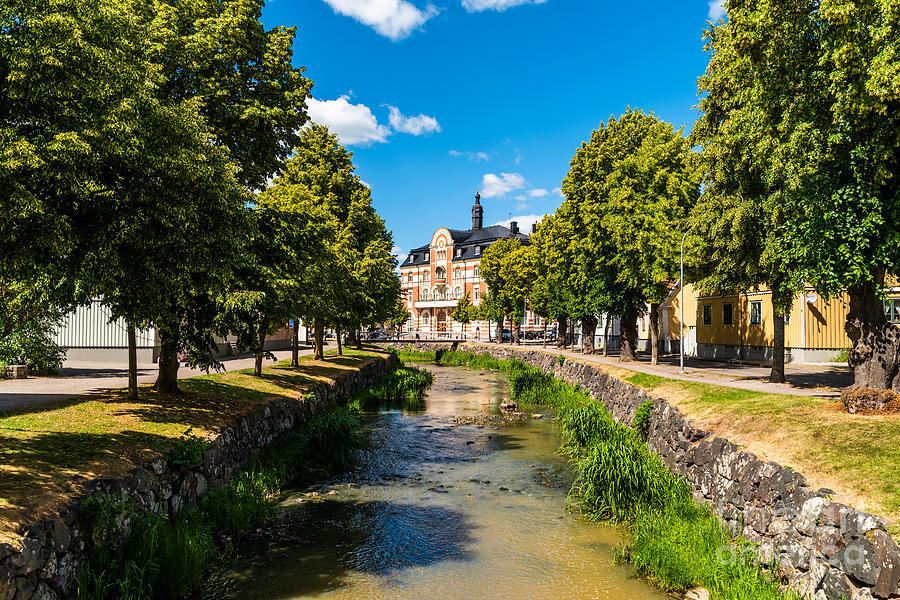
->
left=400, top=352, right=800, bottom=600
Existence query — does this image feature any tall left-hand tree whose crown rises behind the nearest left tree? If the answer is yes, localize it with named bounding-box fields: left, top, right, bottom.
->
left=140, top=0, right=311, bottom=389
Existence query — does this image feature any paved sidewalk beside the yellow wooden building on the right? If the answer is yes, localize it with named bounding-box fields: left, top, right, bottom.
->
left=480, top=342, right=853, bottom=399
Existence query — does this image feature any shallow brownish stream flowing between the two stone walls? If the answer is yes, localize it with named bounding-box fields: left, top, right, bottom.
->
left=203, top=365, right=666, bottom=600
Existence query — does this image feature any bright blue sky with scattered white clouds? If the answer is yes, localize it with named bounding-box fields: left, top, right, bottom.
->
left=263, top=0, right=722, bottom=254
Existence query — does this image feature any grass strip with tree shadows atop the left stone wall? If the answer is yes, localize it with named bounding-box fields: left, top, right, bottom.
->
left=0, top=348, right=384, bottom=542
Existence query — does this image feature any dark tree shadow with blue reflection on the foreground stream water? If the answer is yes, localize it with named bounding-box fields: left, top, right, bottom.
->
left=203, top=499, right=474, bottom=599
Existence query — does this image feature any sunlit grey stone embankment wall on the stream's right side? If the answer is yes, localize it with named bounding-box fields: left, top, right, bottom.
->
left=397, top=344, right=900, bottom=600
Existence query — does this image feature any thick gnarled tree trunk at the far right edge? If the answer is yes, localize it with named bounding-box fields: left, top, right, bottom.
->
left=844, top=284, right=900, bottom=391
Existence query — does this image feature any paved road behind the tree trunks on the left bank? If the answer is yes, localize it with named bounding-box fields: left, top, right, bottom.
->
left=0, top=346, right=330, bottom=411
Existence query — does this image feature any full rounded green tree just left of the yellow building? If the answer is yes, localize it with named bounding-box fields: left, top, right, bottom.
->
left=557, top=109, right=699, bottom=364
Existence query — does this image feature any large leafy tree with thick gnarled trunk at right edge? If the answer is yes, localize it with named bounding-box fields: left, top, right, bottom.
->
left=701, top=0, right=900, bottom=390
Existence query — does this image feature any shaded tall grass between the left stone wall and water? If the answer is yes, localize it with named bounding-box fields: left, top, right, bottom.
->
left=76, top=360, right=432, bottom=600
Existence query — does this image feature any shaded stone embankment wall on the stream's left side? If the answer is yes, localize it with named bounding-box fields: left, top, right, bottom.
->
left=0, top=356, right=395, bottom=600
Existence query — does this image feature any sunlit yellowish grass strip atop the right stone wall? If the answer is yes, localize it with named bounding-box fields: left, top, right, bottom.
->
left=627, top=373, right=900, bottom=535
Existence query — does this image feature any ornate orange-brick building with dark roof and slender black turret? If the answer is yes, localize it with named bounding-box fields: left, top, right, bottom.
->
left=400, top=194, right=542, bottom=337
